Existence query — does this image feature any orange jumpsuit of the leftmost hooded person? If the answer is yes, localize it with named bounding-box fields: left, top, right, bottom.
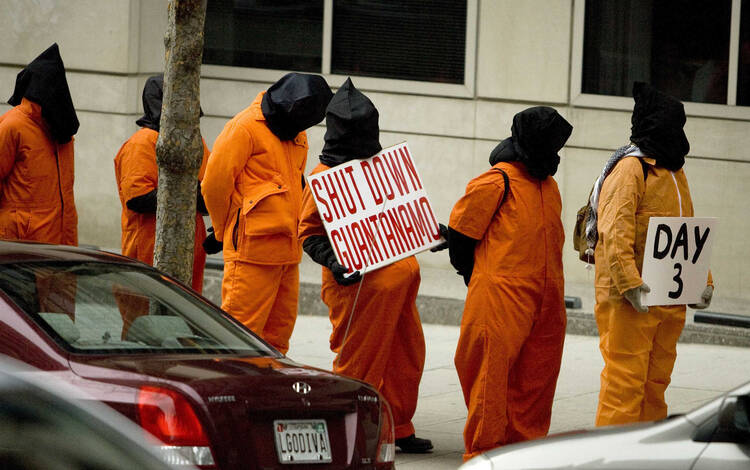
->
left=0, top=98, right=78, bottom=245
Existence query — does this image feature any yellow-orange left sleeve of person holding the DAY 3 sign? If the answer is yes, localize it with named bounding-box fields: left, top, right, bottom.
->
left=596, top=158, right=646, bottom=294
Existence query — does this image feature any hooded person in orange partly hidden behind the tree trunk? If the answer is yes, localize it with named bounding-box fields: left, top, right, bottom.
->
left=115, top=75, right=209, bottom=292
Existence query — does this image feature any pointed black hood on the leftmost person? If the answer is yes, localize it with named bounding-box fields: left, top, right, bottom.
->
left=8, top=43, right=78, bottom=144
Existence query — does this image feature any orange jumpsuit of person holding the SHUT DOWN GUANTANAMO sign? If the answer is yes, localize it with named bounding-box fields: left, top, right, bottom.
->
left=300, top=164, right=425, bottom=439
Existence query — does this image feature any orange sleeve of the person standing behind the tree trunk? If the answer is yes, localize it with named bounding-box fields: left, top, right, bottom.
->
left=120, top=134, right=159, bottom=202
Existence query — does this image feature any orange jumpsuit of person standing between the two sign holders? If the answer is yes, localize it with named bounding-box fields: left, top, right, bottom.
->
left=449, top=162, right=566, bottom=460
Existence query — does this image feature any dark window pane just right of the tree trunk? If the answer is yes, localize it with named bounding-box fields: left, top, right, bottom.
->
left=203, top=0, right=323, bottom=73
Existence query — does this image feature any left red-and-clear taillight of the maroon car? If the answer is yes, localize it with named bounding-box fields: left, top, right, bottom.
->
left=137, top=385, right=215, bottom=467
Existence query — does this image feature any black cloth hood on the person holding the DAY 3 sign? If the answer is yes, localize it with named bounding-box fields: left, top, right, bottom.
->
left=630, top=82, right=690, bottom=171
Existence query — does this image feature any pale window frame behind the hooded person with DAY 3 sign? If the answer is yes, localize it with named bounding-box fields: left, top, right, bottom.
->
left=570, top=0, right=750, bottom=120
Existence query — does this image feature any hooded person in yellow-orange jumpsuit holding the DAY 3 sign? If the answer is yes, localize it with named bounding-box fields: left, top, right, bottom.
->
left=592, top=82, right=713, bottom=425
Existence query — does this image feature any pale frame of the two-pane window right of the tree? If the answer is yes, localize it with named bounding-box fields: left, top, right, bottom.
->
left=201, top=0, right=479, bottom=98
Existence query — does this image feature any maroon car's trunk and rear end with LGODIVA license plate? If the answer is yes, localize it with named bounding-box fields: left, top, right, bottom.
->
left=71, top=356, right=380, bottom=470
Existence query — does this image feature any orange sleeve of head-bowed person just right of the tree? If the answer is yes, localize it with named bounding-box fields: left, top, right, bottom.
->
left=201, top=122, right=253, bottom=240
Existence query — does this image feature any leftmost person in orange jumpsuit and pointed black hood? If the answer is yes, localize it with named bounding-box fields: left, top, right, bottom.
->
left=0, top=44, right=78, bottom=245
